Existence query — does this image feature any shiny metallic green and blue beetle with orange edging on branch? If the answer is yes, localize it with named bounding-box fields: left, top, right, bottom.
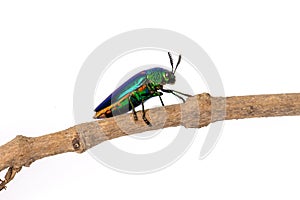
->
left=94, top=52, right=191, bottom=126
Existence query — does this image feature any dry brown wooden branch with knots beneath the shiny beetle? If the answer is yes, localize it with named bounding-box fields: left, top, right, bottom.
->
left=0, top=93, right=300, bottom=190
